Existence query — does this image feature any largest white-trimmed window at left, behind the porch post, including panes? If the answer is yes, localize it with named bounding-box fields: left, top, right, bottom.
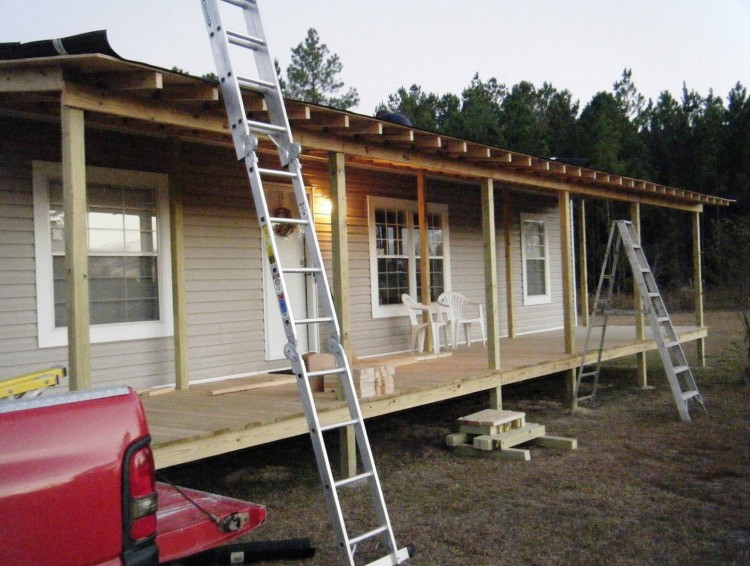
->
left=33, top=162, right=172, bottom=347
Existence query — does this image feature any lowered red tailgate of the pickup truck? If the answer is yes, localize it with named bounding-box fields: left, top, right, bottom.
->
left=156, top=482, right=266, bottom=562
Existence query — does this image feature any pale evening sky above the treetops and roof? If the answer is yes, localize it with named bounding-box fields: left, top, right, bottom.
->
left=0, top=0, right=750, bottom=114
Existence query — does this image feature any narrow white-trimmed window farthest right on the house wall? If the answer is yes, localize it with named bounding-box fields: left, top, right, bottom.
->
left=521, top=214, right=552, bottom=305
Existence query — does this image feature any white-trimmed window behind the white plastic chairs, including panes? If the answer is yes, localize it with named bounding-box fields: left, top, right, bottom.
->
left=368, top=197, right=450, bottom=318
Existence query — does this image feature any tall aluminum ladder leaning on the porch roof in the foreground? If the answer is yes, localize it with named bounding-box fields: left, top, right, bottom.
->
left=201, top=0, right=409, bottom=566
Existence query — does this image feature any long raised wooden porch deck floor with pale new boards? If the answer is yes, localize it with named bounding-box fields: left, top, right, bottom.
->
left=143, top=326, right=708, bottom=468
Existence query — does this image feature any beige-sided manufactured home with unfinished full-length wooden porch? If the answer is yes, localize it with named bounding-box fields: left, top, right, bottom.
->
left=0, top=34, right=729, bottom=466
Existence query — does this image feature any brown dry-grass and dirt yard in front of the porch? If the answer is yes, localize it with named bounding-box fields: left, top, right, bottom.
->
left=166, top=313, right=750, bottom=565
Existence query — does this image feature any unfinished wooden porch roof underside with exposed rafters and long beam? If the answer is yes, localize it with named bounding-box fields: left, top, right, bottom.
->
left=0, top=54, right=732, bottom=210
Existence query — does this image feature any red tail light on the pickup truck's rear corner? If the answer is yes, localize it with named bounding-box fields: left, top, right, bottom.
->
left=126, top=444, right=158, bottom=542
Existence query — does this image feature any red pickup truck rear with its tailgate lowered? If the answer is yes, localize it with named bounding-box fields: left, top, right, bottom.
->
left=0, top=387, right=266, bottom=566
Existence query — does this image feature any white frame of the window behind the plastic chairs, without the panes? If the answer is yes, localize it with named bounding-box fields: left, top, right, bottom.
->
left=367, top=196, right=451, bottom=318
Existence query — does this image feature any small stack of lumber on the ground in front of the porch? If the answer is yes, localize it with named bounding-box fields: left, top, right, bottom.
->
left=445, top=409, right=578, bottom=460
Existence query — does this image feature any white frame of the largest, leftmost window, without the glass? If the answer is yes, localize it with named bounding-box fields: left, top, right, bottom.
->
left=32, top=161, right=174, bottom=348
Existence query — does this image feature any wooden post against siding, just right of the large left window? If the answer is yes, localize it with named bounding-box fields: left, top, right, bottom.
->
left=169, top=138, right=190, bottom=389
